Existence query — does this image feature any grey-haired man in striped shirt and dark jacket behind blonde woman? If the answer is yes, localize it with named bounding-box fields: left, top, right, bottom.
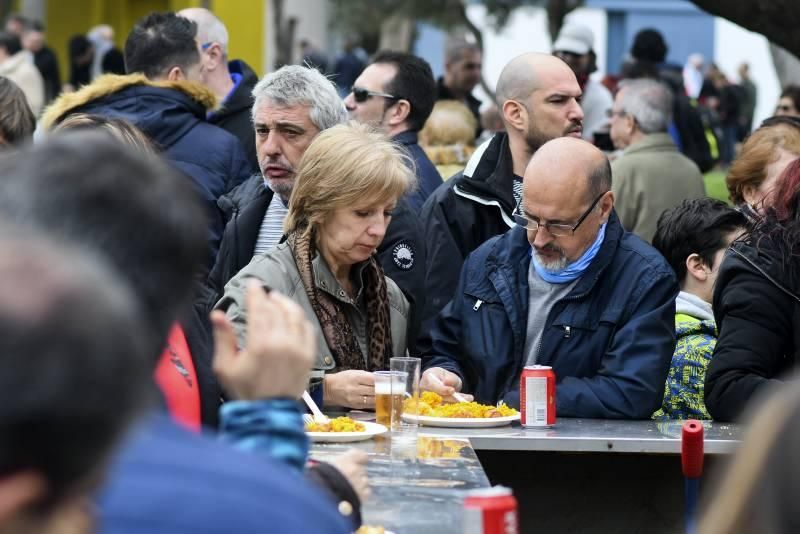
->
left=203, top=65, right=425, bottom=345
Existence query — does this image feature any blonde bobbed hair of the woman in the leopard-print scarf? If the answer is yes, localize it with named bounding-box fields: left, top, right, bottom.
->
left=283, top=121, right=416, bottom=240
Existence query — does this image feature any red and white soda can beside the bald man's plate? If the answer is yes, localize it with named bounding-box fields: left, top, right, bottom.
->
left=519, top=365, right=556, bottom=428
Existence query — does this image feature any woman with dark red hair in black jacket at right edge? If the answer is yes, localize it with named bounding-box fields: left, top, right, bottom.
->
left=705, top=159, right=800, bottom=420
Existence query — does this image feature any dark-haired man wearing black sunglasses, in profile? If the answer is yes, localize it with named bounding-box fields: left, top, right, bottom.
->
left=344, top=51, right=442, bottom=212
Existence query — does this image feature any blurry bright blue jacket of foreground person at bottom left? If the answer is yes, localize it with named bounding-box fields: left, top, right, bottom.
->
left=97, top=414, right=352, bottom=534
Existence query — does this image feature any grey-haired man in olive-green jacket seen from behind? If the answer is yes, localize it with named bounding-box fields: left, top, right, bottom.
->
left=608, top=79, right=706, bottom=242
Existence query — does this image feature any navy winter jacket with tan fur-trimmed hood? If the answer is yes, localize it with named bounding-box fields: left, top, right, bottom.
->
left=42, top=74, right=250, bottom=262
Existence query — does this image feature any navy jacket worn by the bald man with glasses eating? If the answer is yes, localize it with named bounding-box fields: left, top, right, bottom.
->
left=423, top=212, right=678, bottom=419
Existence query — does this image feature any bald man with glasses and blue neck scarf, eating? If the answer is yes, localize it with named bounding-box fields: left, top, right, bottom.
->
left=421, top=138, right=678, bottom=419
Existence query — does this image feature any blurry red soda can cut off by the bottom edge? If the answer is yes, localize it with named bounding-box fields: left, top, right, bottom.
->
left=463, top=486, right=519, bottom=534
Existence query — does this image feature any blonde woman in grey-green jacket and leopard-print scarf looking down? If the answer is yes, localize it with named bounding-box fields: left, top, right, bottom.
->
left=217, top=123, right=415, bottom=408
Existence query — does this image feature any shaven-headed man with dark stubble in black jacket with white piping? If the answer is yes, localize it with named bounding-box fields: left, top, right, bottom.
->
left=417, top=53, right=583, bottom=351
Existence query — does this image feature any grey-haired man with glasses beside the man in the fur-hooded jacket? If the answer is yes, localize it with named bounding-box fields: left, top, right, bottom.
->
left=178, top=7, right=259, bottom=173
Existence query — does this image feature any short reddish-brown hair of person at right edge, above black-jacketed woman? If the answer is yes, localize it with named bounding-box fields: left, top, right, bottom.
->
left=725, top=123, right=800, bottom=204
